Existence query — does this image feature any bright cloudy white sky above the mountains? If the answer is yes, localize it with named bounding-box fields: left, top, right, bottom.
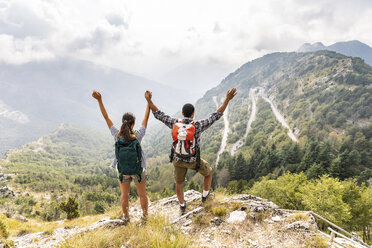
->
left=0, top=0, right=372, bottom=95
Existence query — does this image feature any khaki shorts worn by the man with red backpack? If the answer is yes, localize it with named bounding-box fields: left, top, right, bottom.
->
left=173, top=158, right=211, bottom=184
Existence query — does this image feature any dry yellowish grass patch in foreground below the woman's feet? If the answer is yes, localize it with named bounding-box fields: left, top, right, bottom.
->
left=59, top=215, right=192, bottom=248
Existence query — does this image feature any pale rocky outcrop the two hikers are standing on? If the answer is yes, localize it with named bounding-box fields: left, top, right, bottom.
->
left=8, top=190, right=366, bottom=248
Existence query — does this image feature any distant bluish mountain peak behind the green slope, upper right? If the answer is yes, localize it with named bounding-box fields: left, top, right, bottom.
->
left=297, top=40, right=372, bottom=65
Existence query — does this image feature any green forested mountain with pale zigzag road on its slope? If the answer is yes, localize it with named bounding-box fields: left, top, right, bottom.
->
left=144, top=51, right=372, bottom=182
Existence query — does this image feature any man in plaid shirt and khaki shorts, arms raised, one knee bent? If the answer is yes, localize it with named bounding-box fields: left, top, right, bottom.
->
left=145, top=88, right=236, bottom=214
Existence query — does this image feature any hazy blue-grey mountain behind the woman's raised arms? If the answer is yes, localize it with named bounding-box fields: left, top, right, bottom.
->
left=0, top=59, right=188, bottom=155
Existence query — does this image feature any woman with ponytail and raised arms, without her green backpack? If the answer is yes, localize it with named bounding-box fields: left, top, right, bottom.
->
left=92, top=91, right=150, bottom=223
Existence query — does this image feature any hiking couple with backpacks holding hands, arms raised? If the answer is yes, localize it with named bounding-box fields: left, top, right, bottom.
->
left=92, top=88, right=237, bottom=222
